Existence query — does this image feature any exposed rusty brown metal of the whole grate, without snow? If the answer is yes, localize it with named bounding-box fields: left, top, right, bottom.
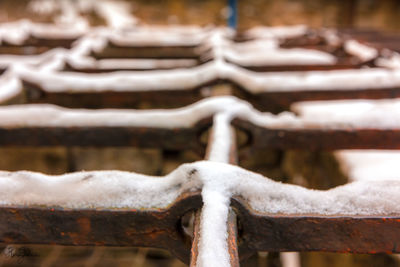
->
left=0, top=22, right=400, bottom=266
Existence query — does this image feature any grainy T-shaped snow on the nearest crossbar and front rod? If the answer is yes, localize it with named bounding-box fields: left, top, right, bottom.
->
left=0, top=162, right=400, bottom=266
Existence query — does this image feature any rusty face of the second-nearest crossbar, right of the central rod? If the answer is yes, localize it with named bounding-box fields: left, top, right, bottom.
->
left=234, top=120, right=400, bottom=150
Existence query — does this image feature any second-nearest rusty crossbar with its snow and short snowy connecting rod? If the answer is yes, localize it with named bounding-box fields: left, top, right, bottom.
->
left=0, top=96, right=400, bottom=153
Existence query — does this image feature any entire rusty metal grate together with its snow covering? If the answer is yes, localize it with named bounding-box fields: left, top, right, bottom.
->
left=0, top=19, right=400, bottom=266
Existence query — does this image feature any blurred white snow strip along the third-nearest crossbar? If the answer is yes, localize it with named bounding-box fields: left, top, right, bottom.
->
left=16, top=61, right=400, bottom=96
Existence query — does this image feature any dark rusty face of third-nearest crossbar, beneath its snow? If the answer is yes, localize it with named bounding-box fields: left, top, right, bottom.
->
left=23, top=77, right=400, bottom=112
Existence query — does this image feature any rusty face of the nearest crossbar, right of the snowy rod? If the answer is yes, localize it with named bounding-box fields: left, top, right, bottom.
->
left=232, top=198, right=400, bottom=254
